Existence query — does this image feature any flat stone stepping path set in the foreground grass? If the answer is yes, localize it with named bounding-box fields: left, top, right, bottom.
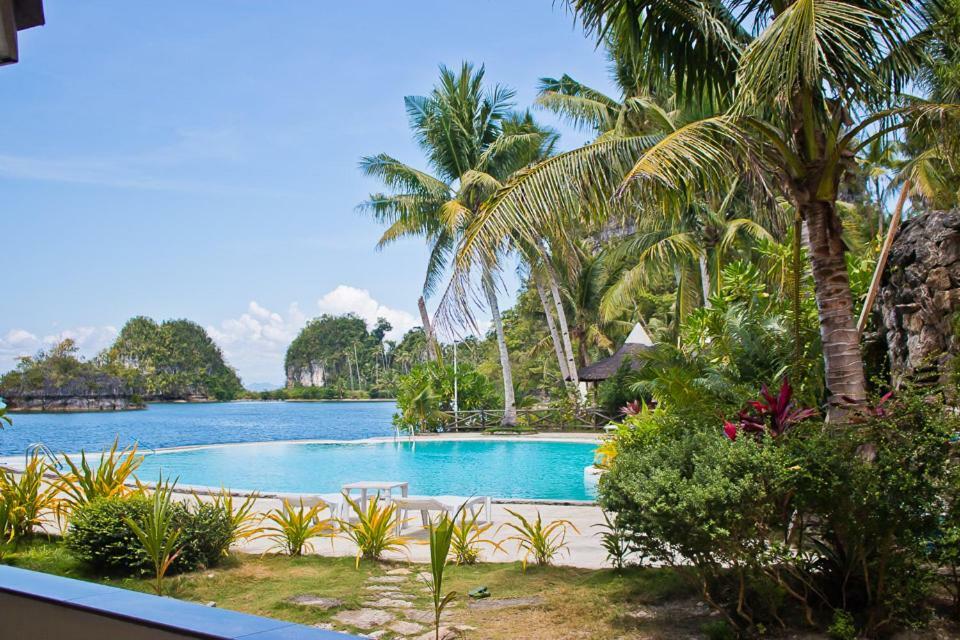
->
left=320, top=568, right=478, bottom=640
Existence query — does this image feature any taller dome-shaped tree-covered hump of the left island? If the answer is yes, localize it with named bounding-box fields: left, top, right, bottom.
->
left=101, top=316, right=243, bottom=400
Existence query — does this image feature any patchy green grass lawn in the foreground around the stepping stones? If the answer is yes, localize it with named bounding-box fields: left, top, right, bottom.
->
left=3, top=539, right=716, bottom=640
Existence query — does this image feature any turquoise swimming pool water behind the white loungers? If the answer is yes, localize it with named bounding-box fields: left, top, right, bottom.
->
left=137, top=439, right=596, bottom=500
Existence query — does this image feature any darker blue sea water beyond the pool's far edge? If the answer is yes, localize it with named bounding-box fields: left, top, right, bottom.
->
left=0, top=402, right=396, bottom=455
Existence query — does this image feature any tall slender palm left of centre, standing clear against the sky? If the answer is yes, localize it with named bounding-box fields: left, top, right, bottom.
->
left=360, top=63, right=555, bottom=425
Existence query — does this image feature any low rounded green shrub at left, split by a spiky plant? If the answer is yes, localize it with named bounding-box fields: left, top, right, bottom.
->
left=66, top=494, right=231, bottom=575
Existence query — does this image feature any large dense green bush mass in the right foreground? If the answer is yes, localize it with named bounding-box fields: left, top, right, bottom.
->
left=600, top=394, right=958, bottom=634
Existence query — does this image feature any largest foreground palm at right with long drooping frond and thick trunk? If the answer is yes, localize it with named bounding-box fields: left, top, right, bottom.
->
left=457, top=0, right=956, bottom=417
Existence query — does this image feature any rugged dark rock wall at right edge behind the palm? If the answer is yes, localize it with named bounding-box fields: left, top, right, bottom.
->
left=879, top=211, right=960, bottom=386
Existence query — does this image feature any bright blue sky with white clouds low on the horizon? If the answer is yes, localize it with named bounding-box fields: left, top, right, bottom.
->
left=0, top=0, right=616, bottom=384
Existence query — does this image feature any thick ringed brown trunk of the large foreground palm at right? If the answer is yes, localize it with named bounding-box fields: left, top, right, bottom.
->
left=799, top=200, right=867, bottom=419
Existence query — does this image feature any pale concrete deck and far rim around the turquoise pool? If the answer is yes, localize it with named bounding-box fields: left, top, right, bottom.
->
left=0, top=432, right=610, bottom=569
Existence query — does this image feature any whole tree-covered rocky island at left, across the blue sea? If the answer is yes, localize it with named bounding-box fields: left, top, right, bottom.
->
left=0, top=316, right=243, bottom=412
